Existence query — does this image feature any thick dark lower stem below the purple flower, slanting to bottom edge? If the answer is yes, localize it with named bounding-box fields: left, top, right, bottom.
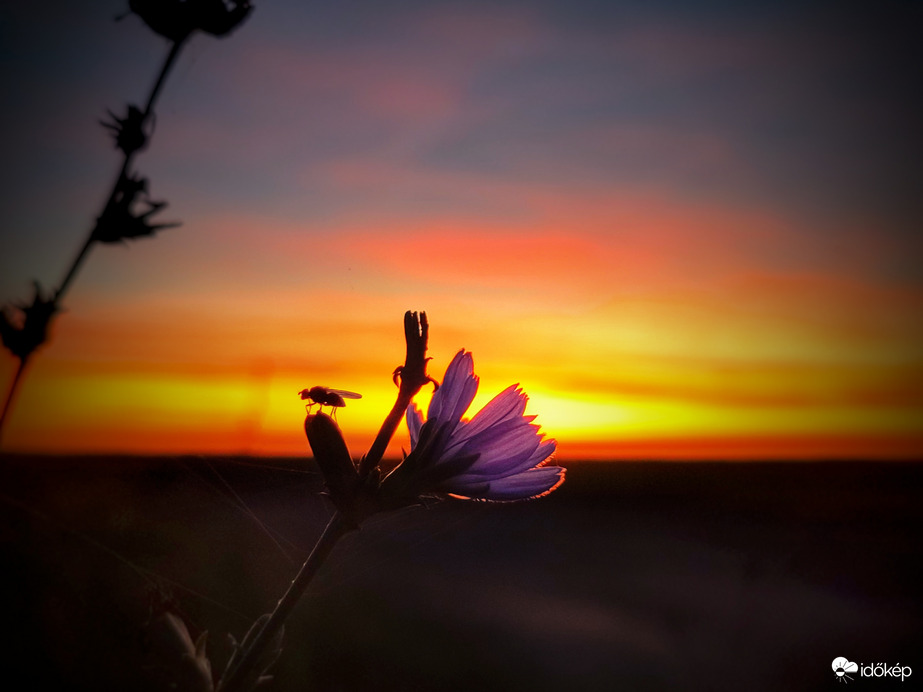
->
left=218, top=511, right=354, bottom=692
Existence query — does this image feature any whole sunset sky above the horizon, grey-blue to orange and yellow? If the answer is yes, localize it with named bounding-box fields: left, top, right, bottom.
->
left=0, top=0, right=923, bottom=461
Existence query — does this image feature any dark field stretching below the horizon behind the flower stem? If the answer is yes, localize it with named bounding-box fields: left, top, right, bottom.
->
left=0, top=457, right=923, bottom=692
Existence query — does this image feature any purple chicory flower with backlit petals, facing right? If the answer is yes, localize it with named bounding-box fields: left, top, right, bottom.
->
left=380, top=350, right=564, bottom=506
